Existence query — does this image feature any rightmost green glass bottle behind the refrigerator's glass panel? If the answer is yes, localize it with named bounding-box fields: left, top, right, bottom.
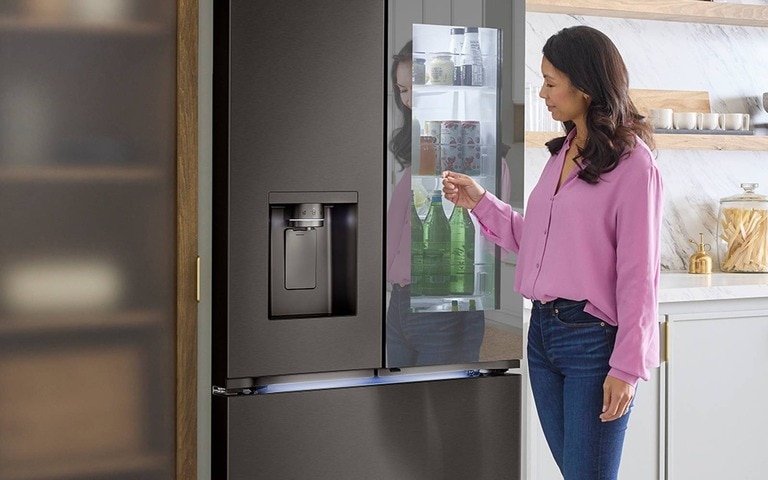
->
left=449, top=206, right=475, bottom=295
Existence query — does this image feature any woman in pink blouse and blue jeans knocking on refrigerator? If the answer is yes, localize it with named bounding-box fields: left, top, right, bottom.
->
left=443, top=26, right=663, bottom=480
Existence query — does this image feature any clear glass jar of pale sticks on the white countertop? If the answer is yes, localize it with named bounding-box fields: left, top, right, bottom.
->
left=717, top=183, right=768, bottom=272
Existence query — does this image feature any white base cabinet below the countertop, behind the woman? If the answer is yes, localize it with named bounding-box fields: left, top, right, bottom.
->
left=523, top=297, right=768, bottom=480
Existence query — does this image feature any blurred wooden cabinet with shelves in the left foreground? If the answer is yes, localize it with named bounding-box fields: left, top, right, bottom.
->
left=0, top=0, right=197, bottom=480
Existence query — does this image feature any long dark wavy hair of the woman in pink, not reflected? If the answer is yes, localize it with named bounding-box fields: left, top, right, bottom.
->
left=542, top=25, right=655, bottom=184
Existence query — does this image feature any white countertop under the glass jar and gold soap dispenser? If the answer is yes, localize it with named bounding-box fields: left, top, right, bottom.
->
left=659, top=272, right=768, bottom=303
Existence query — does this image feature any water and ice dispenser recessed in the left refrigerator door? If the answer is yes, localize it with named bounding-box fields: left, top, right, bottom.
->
left=269, top=192, right=358, bottom=319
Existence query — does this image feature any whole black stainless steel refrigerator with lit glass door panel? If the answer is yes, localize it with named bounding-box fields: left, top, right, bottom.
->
left=212, top=0, right=521, bottom=480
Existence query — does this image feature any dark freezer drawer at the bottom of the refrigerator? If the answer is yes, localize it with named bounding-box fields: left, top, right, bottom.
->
left=212, top=375, right=521, bottom=480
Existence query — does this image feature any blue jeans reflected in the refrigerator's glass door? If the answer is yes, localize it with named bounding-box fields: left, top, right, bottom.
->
left=387, top=284, right=485, bottom=367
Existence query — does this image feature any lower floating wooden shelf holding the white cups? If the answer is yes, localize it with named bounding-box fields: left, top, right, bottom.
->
left=525, top=132, right=768, bottom=151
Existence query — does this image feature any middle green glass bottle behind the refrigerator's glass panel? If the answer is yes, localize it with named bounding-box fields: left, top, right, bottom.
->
left=421, top=190, right=451, bottom=296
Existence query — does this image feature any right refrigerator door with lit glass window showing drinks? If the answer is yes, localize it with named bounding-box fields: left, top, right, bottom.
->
left=386, top=15, right=522, bottom=368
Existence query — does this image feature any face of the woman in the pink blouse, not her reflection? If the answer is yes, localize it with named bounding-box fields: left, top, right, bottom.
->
left=539, top=57, right=589, bottom=123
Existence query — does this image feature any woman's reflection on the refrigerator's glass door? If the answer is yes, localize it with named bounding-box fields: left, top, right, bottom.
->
left=387, top=42, right=485, bottom=367
